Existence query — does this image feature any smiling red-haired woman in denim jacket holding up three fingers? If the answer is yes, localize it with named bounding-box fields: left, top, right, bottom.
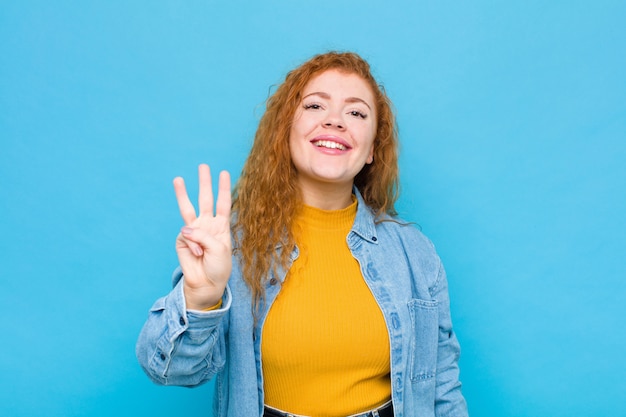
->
left=137, top=52, right=467, bottom=417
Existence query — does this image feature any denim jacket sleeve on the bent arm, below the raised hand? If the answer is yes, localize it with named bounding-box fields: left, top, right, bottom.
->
left=136, top=269, right=231, bottom=386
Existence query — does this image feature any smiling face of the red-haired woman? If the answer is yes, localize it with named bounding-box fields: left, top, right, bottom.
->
left=289, top=70, right=376, bottom=202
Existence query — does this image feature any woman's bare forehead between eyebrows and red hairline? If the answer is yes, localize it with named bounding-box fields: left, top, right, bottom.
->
left=303, top=69, right=375, bottom=106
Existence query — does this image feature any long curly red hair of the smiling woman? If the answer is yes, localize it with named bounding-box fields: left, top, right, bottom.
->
left=233, top=52, right=398, bottom=304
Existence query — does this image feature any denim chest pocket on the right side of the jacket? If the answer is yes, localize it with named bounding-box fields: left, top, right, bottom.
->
left=408, top=298, right=439, bottom=382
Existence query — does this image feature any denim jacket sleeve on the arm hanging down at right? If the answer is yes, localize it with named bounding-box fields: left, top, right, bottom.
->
left=431, top=263, right=468, bottom=417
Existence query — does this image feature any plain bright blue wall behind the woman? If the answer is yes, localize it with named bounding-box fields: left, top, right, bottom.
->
left=0, top=0, right=626, bottom=417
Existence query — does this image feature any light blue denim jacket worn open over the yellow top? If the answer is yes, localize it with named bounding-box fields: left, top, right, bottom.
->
left=136, top=190, right=467, bottom=417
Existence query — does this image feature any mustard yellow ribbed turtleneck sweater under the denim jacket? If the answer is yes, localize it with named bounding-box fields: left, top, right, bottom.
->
left=261, top=201, right=391, bottom=417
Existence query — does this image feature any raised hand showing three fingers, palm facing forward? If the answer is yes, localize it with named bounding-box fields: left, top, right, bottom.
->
left=174, top=164, right=232, bottom=310
